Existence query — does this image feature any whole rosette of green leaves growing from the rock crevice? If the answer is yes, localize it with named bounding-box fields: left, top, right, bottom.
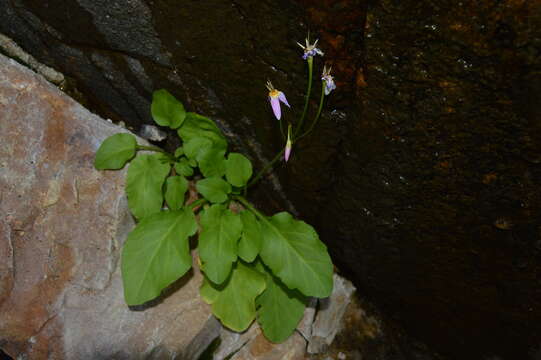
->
left=95, top=90, right=333, bottom=342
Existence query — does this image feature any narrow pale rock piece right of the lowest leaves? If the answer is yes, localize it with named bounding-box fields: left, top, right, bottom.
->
left=308, top=274, right=355, bottom=354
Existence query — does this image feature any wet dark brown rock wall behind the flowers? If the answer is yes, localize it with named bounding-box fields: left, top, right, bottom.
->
left=0, top=0, right=541, bottom=359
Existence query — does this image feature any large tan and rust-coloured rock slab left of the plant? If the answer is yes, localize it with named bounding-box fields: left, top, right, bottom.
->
left=0, top=55, right=219, bottom=359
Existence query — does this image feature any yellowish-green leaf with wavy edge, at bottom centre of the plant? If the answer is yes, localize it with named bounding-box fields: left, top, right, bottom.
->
left=200, top=261, right=265, bottom=332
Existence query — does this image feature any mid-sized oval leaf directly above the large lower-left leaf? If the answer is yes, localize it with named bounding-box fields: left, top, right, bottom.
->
left=126, top=154, right=171, bottom=219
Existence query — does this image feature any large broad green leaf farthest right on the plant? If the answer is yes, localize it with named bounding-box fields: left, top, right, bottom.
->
left=260, top=212, right=333, bottom=298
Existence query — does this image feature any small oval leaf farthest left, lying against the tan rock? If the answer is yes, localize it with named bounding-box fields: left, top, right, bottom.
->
left=94, top=134, right=137, bottom=170
